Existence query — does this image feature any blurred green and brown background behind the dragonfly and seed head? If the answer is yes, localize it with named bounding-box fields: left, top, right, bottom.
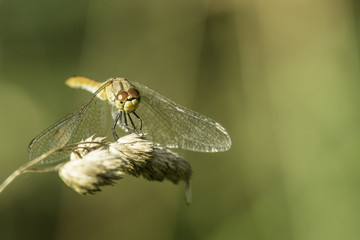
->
left=0, top=0, right=360, bottom=240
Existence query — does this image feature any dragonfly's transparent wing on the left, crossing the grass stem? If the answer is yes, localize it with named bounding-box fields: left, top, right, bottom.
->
left=28, top=86, right=110, bottom=168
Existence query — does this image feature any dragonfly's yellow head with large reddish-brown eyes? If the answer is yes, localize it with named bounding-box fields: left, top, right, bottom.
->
left=115, top=88, right=140, bottom=113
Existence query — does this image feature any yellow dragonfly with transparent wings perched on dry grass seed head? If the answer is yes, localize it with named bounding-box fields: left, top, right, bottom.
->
left=28, top=76, right=231, bottom=165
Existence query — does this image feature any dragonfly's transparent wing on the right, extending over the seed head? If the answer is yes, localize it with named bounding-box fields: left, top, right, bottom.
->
left=122, top=81, right=231, bottom=152
